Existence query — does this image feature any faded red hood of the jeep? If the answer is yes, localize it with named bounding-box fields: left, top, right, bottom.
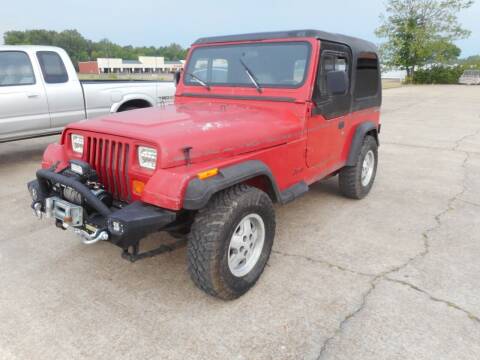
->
left=68, top=103, right=302, bottom=168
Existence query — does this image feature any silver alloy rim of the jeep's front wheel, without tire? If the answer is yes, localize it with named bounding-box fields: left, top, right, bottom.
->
left=228, top=214, right=265, bottom=277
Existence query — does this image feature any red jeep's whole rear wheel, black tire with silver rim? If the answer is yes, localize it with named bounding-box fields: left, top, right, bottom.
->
left=339, top=136, right=378, bottom=199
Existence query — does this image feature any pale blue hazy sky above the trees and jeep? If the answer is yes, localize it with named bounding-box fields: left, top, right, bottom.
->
left=0, top=0, right=480, bottom=56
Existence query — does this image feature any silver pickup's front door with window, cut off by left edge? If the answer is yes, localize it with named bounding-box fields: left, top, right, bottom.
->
left=0, top=50, right=50, bottom=141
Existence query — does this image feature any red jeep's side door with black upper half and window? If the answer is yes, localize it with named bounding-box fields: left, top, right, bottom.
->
left=307, top=41, right=351, bottom=172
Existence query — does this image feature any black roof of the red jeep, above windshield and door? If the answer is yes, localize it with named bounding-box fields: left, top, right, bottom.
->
left=193, top=30, right=377, bottom=56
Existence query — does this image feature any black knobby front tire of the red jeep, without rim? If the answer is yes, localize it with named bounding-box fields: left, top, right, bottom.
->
left=187, top=185, right=275, bottom=300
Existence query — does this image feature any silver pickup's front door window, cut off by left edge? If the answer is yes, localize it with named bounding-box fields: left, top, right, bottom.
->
left=0, top=51, right=35, bottom=86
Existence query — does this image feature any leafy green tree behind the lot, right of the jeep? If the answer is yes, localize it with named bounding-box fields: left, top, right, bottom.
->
left=376, top=0, right=473, bottom=78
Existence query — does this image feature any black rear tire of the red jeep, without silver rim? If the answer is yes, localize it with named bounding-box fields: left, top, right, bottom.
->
left=338, top=135, right=378, bottom=199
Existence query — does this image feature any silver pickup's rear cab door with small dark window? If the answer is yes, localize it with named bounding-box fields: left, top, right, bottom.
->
left=37, top=51, right=85, bottom=129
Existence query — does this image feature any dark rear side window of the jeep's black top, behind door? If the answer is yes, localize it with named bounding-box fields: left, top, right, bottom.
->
left=354, top=54, right=379, bottom=99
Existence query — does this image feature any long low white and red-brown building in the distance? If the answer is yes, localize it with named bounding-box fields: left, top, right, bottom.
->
left=78, top=56, right=185, bottom=74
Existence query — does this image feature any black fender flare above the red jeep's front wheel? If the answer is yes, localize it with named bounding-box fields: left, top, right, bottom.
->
left=183, top=160, right=282, bottom=210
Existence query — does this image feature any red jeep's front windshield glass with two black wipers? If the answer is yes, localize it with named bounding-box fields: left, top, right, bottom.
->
left=184, top=41, right=310, bottom=89
